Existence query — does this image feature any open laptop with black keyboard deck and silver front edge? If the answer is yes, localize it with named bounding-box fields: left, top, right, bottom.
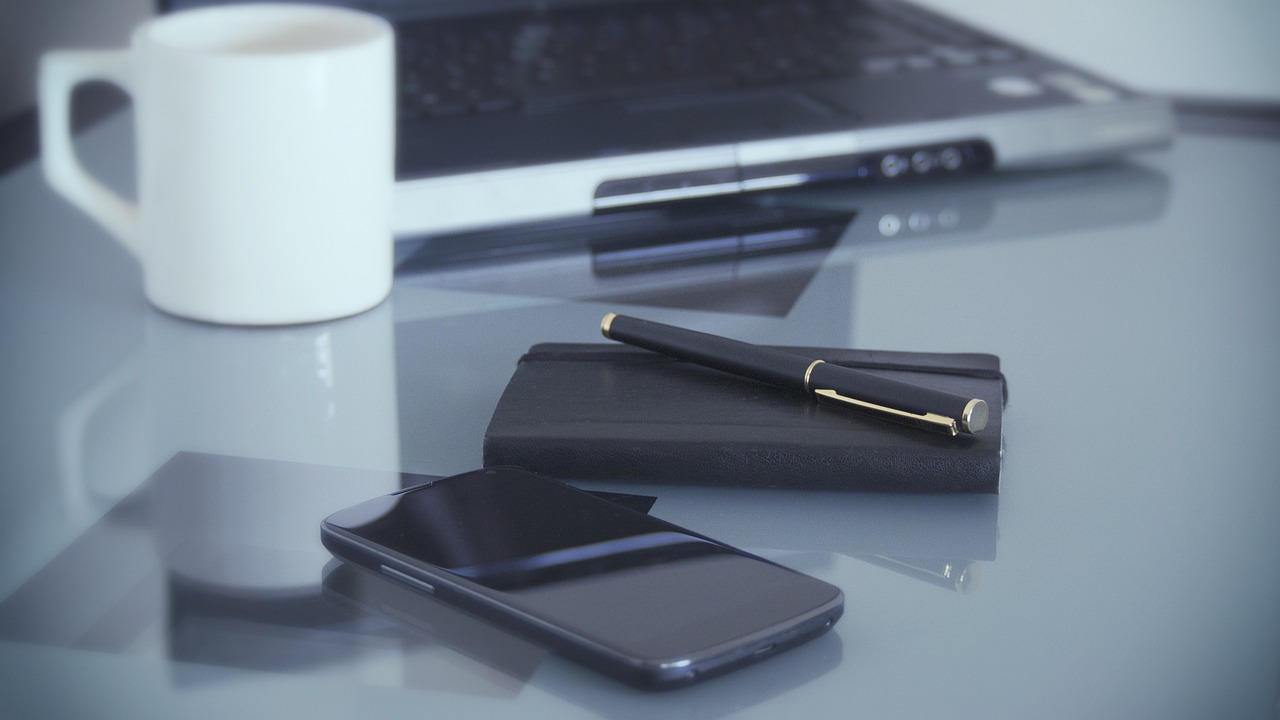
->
left=160, top=0, right=1174, bottom=238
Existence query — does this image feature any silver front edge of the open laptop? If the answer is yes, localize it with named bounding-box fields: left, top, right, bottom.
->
left=393, top=96, right=1174, bottom=238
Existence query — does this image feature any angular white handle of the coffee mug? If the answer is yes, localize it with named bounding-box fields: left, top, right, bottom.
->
left=37, top=50, right=141, bottom=256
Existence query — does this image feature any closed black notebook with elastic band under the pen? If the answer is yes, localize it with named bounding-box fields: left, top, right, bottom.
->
left=484, top=343, right=1006, bottom=493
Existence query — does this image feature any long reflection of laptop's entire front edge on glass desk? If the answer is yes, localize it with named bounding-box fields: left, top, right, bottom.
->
left=397, top=164, right=1169, bottom=318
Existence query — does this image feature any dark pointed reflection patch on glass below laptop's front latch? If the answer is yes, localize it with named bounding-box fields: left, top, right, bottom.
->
left=397, top=197, right=854, bottom=316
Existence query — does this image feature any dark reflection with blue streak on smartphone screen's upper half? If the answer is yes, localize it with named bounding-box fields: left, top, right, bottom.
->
left=325, top=469, right=730, bottom=594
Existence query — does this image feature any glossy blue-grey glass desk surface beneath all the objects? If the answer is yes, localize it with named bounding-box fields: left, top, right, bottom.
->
left=0, top=109, right=1280, bottom=719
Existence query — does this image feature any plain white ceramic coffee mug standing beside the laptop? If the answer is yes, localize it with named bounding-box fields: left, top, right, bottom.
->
left=38, top=5, right=396, bottom=325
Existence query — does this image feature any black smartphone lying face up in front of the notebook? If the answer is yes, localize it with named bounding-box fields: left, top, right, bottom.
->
left=321, top=468, right=844, bottom=689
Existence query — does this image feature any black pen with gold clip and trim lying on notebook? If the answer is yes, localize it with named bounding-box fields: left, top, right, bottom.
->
left=600, top=313, right=987, bottom=436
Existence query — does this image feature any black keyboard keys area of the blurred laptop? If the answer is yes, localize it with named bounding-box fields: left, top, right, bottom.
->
left=397, top=0, right=1020, bottom=118
